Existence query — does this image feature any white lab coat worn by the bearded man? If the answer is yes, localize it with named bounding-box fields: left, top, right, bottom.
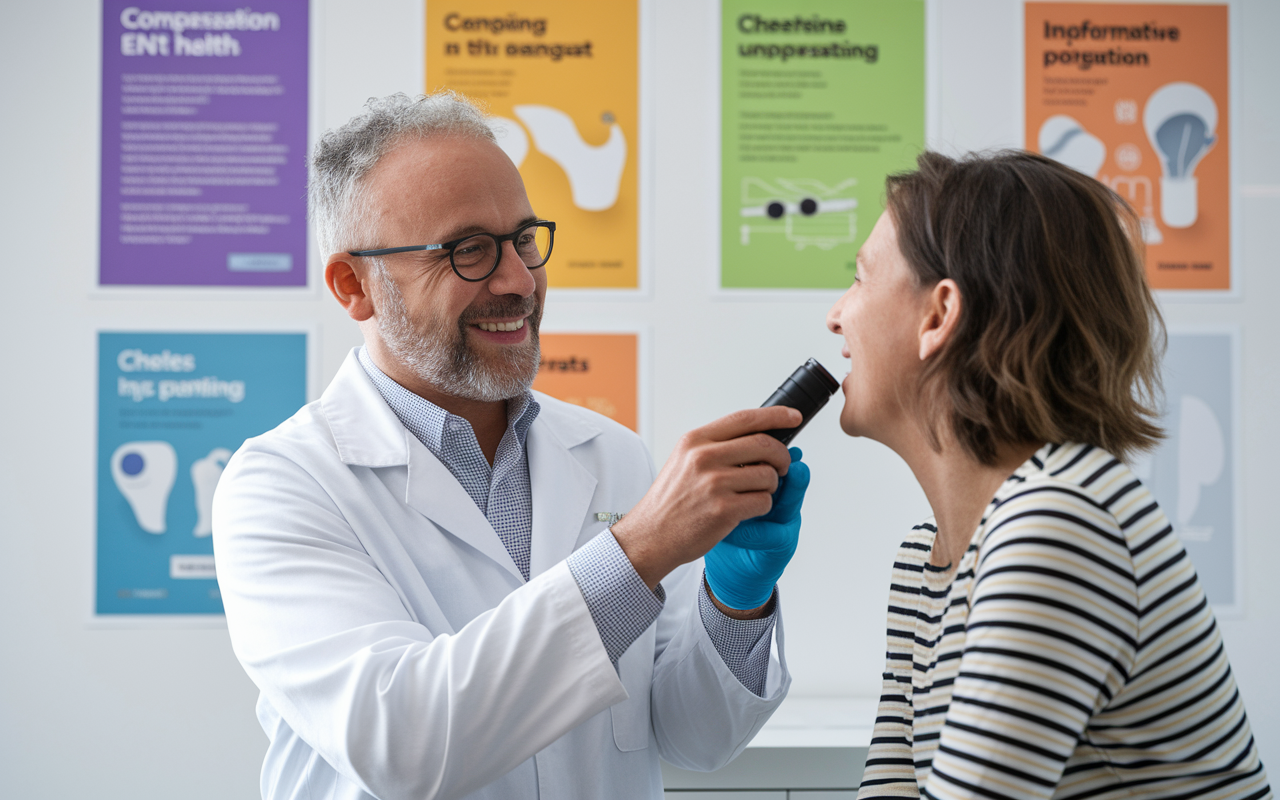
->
left=214, top=353, right=790, bottom=800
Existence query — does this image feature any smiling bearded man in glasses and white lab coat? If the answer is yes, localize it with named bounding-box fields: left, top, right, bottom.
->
left=214, top=93, right=808, bottom=800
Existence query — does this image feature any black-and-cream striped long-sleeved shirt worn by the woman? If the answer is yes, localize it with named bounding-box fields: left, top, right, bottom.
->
left=858, top=444, right=1272, bottom=800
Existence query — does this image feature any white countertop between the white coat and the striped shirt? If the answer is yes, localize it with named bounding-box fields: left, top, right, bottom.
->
left=748, top=696, right=879, bottom=748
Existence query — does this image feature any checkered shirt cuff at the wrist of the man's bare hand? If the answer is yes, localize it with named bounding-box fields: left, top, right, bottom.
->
left=566, top=530, right=667, bottom=667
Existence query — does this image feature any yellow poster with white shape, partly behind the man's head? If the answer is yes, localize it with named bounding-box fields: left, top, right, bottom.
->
left=426, top=0, right=640, bottom=289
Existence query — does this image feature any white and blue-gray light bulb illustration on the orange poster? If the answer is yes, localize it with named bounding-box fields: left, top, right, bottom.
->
left=1142, top=83, right=1217, bottom=228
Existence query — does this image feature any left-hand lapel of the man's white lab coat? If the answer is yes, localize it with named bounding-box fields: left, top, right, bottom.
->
left=320, top=349, right=525, bottom=582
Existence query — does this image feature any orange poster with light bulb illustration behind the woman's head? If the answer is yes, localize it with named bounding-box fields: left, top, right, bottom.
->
left=1025, top=3, right=1231, bottom=291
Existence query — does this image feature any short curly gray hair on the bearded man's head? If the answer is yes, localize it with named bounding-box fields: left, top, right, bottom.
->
left=307, top=91, right=497, bottom=257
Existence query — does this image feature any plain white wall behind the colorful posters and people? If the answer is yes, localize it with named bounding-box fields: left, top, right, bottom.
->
left=0, top=0, right=1280, bottom=800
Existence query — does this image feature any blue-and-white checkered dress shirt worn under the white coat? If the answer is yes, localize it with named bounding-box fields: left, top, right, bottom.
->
left=358, top=347, right=777, bottom=695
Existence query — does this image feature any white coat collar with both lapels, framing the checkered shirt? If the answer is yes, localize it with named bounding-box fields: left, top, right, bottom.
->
left=320, top=349, right=602, bottom=581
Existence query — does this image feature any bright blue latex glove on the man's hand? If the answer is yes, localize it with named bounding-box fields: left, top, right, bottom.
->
left=705, top=447, right=809, bottom=611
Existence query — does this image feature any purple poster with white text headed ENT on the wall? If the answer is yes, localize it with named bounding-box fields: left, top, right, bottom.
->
left=99, top=0, right=307, bottom=287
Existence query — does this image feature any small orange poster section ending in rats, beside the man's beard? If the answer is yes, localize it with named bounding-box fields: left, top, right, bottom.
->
left=534, top=333, right=640, bottom=430
